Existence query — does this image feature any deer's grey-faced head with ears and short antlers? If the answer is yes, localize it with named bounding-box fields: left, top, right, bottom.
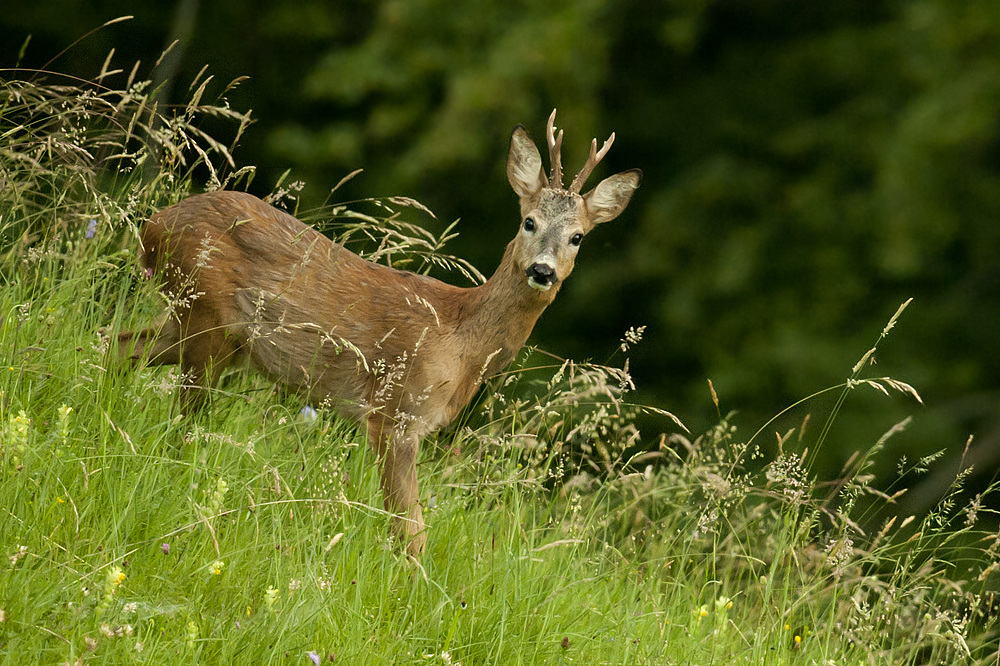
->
left=507, top=109, right=642, bottom=297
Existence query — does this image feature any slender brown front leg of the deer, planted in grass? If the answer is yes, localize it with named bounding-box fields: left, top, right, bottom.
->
left=368, top=413, right=427, bottom=557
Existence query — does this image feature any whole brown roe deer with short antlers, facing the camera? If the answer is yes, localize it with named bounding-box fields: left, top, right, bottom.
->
left=118, top=111, right=642, bottom=556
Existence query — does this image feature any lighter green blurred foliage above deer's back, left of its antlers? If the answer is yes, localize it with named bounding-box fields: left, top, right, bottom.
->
left=268, top=0, right=623, bottom=226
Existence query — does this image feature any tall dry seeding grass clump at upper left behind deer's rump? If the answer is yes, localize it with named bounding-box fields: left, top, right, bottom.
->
left=0, top=53, right=252, bottom=256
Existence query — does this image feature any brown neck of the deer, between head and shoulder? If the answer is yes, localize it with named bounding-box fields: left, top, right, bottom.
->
left=465, top=239, right=559, bottom=377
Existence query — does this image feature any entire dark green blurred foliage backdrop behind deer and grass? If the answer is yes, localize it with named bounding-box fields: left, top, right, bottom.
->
left=0, top=0, right=1000, bottom=505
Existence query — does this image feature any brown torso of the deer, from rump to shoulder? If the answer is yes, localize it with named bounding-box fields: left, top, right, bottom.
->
left=142, top=192, right=488, bottom=437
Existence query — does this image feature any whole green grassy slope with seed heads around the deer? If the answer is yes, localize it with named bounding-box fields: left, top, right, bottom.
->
left=0, top=59, right=1000, bottom=665
